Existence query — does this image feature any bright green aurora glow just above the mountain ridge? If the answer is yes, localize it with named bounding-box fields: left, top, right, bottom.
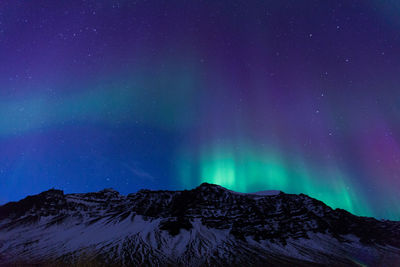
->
left=178, top=144, right=372, bottom=216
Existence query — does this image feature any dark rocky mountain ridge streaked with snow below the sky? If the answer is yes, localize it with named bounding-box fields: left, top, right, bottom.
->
left=0, top=183, right=400, bottom=266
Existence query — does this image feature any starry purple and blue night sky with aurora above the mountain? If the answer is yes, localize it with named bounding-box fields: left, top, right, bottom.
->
left=0, top=0, right=400, bottom=220
